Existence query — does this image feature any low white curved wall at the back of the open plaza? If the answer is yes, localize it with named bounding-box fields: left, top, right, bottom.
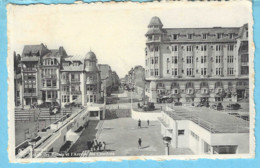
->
left=131, top=109, right=162, bottom=121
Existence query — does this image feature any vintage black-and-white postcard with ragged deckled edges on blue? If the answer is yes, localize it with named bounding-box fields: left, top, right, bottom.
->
left=7, top=1, right=255, bottom=163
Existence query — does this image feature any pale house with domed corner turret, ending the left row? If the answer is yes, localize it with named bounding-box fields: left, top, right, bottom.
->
left=60, top=51, right=101, bottom=105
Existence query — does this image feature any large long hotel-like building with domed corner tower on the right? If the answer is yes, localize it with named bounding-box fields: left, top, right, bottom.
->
left=145, top=17, right=249, bottom=103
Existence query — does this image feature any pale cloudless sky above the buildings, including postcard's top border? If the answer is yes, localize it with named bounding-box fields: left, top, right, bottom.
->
left=7, top=1, right=251, bottom=77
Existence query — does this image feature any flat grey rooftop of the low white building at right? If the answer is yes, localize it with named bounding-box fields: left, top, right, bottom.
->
left=165, top=106, right=249, bottom=133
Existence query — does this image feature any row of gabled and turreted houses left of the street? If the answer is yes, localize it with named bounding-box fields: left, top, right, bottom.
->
left=14, top=44, right=118, bottom=107
